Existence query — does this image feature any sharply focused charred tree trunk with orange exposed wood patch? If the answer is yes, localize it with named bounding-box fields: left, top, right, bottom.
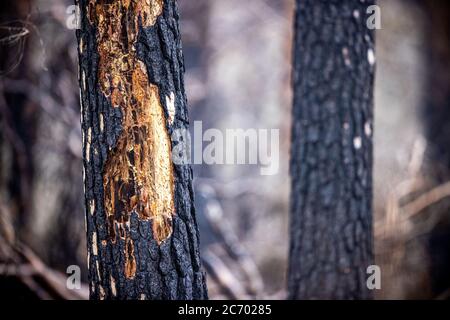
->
left=77, top=0, right=207, bottom=299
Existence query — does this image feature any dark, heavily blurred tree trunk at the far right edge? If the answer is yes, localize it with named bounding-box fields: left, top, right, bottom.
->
left=419, top=0, right=450, bottom=296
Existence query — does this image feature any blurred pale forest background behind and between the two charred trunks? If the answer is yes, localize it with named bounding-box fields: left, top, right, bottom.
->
left=0, top=0, right=450, bottom=299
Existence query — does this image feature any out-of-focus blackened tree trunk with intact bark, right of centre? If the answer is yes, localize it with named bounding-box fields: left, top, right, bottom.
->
left=288, top=0, right=375, bottom=299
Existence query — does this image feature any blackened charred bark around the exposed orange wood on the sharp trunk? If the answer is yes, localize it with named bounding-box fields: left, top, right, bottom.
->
left=77, top=0, right=207, bottom=299
